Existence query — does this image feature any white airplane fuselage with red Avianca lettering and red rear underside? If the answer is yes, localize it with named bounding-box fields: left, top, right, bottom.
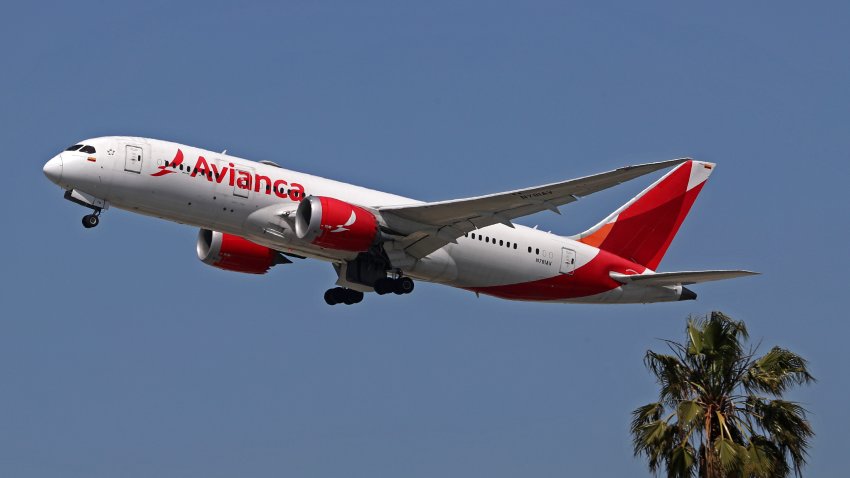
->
left=44, top=137, right=680, bottom=302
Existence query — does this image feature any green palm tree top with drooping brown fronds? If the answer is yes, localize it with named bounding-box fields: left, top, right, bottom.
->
left=631, top=312, right=814, bottom=478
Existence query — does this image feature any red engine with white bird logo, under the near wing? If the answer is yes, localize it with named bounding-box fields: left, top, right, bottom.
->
left=295, top=196, right=378, bottom=252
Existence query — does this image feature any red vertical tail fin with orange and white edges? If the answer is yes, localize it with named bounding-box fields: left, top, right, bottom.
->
left=571, top=160, right=714, bottom=270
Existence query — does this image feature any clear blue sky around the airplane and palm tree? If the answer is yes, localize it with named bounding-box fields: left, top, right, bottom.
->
left=0, top=1, right=850, bottom=477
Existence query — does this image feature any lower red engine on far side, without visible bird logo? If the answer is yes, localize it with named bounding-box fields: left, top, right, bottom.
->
left=197, top=229, right=283, bottom=274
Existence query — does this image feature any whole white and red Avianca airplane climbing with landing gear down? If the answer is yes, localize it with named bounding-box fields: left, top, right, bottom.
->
left=43, top=136, right=757, bottom=305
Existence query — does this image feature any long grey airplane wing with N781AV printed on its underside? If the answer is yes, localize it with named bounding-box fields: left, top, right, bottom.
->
left=378, top=158, right=690, bottom=259
